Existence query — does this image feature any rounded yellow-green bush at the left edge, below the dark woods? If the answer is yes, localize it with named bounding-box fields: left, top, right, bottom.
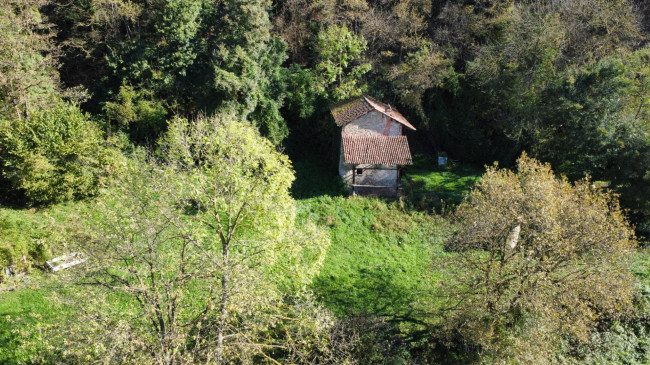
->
left=0, top=103, right=119, bottom=203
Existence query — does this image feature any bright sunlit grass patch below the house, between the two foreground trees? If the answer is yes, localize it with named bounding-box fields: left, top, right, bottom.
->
left=298, top=197, right=451, bottom=318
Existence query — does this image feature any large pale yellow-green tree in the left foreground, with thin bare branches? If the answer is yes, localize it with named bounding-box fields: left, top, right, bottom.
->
left=39, top=114, right=348, bottom=364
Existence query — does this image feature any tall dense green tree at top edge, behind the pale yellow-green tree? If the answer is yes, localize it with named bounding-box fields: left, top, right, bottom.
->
left=198, top=0, right=288, bottom=144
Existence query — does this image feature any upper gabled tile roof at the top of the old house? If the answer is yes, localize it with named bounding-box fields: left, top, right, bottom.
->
left=331, top=95, right=415, bottom=130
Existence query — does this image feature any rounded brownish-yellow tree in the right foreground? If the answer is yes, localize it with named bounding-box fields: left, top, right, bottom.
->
left=448, top=155, right=636, bottom=361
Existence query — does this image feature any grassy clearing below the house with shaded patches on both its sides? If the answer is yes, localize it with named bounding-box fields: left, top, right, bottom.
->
left=292, top=156, right=482, bottom=320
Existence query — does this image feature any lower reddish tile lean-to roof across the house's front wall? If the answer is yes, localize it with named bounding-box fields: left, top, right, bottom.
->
left=343, top=136, right=413, bottom=165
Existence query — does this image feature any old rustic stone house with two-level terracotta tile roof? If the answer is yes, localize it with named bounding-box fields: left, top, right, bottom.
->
left=332, top=95, right=415, bottom=195
